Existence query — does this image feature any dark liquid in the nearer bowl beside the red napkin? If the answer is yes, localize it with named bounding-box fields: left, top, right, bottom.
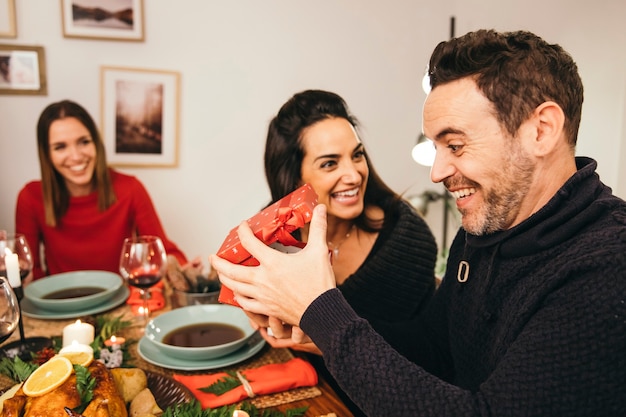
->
left=163, top=323, right=244, bottom=347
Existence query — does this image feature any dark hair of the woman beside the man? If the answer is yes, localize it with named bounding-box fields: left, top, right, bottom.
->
left=265, top=90, right=400, bottom=232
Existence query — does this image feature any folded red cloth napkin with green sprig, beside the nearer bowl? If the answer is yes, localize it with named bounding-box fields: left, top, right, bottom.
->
left=173, top=358, right=317, bottom=408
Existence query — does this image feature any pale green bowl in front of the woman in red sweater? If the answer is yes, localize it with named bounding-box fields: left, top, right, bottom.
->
left=24, top=271, right=124, bottom=312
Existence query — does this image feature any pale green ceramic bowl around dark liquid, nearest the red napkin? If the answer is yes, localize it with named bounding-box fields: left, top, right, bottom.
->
left=144, top=304, right=255, bottom=360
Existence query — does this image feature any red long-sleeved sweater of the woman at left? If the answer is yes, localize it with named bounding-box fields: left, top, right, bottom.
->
left=15, top=170, right=187, bottom=279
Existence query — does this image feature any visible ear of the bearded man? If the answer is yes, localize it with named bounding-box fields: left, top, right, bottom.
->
left=530, top=101, right=566, bottom=156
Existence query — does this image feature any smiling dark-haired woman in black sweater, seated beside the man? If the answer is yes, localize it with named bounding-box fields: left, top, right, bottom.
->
left=258, top=90, right=437, bottom=416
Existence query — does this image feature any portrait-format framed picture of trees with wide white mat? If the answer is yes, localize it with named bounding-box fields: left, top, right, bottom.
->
left=100, top=66, right=180, bottom=167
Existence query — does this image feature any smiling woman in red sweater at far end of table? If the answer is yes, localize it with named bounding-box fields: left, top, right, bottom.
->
left=15, top=100, right=187, bottom=279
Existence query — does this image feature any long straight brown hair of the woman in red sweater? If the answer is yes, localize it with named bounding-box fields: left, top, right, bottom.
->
left=37, top=100, right=116, bottom=227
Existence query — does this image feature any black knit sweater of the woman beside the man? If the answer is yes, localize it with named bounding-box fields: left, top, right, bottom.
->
left=308, top=202, right=437, bottom=417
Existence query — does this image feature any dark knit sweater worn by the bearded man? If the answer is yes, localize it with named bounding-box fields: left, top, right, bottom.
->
left=300, top=158, right=626, bottom=417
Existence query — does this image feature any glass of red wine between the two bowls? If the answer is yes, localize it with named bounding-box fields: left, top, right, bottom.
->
left=120, top=236, right=167, bottom=324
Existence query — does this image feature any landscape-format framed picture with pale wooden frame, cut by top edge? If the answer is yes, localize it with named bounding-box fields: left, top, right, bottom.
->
left=61, top=0, right=144, bottom=41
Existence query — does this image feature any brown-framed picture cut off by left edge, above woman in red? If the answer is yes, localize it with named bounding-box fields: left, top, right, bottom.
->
left=0, top=45, right=48, bottom=96
